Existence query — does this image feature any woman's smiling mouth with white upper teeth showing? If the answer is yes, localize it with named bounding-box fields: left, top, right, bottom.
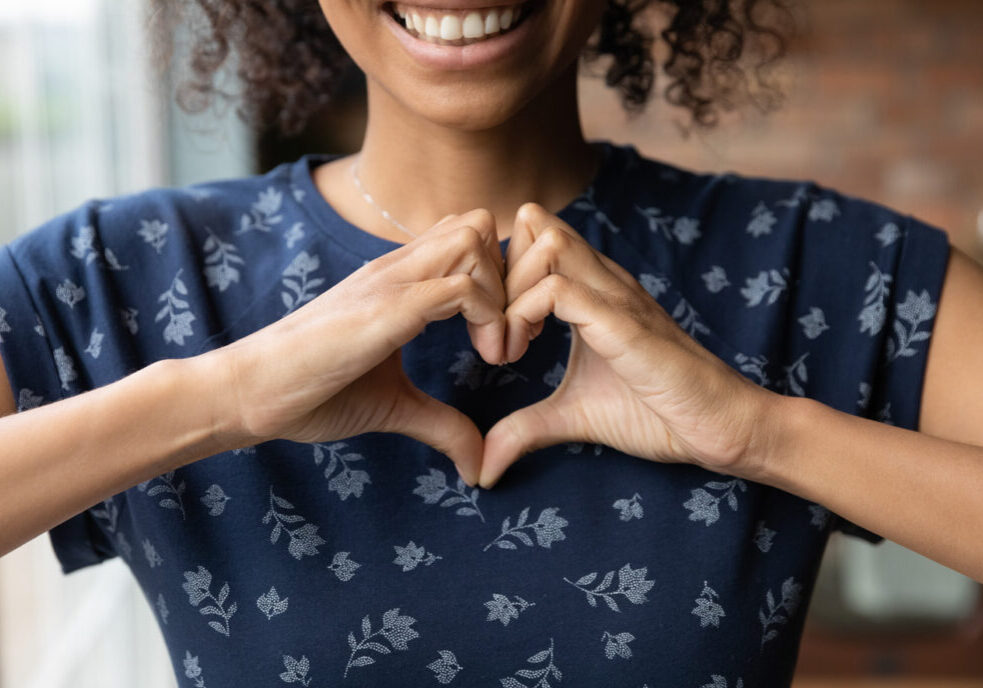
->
left=382, top=0, right=537, bottom=46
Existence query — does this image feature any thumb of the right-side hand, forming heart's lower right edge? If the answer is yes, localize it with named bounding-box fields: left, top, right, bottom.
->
left=478, top=397, right=579, bottom=488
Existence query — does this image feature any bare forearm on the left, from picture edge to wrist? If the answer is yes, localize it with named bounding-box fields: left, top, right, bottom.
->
left=0, top=356, right=237, bottom=556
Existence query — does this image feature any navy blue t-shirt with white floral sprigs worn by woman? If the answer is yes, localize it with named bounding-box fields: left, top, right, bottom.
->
left=0, top=141, right=949, bottom=688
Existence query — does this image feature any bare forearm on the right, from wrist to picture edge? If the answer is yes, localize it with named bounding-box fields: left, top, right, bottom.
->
left=749, top=397, right=983, bottom=581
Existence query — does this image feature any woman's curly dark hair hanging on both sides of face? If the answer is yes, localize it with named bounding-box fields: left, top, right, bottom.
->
left=148, top=0, right=795, bottom=137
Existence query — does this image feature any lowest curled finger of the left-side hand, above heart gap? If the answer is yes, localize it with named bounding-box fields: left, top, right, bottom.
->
left=412, top=273, right=505, bottom=365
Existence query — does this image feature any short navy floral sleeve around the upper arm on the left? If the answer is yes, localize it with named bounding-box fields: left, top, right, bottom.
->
left=0, top=215, right=116, bottom=573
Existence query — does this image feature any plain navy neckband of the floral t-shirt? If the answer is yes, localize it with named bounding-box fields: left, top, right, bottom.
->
left=290, top=139, right=633, bottom=260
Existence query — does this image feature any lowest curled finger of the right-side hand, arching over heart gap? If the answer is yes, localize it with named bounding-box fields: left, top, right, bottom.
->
left=505, top=273, right=640, bottom=363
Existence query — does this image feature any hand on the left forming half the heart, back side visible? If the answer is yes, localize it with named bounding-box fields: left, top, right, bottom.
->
left=213, top=209, right=505, bottom=485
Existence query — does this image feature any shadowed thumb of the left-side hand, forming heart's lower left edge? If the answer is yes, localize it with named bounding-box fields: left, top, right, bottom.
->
left=384, top=383, right=484, bottom=487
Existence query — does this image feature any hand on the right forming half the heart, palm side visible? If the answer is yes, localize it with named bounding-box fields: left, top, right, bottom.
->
left=479, top=203, right=782, bottom=488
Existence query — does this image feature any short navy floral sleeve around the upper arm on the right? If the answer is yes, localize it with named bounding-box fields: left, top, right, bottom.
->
left=834, top=211, right=950, bottom=543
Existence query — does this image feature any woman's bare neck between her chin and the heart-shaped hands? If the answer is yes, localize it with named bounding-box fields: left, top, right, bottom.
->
left=359, top=64, right=600, bottom=240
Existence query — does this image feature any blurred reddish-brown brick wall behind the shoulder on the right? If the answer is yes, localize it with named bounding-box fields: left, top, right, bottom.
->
left=581, top=0, right=983, bottom=262
